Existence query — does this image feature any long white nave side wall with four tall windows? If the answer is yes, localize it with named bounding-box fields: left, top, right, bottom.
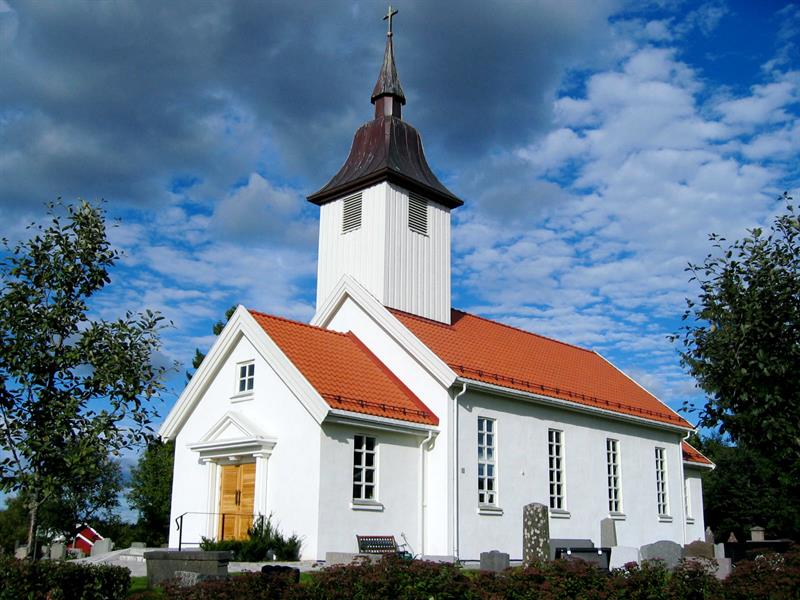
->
left=458, top=390, right=684, bottom=560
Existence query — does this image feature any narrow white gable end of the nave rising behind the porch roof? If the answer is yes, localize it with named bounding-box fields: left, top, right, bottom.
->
left=328, top=299, right=453, bottom=555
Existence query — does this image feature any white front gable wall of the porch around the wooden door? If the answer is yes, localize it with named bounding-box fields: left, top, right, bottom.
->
left=169, top=337, right=320, bottom=558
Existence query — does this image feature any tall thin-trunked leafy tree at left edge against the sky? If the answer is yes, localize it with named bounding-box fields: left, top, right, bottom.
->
left=0, top=202, right=165, bottom=549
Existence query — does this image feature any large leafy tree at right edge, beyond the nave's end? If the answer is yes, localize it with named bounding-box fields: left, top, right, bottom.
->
left=680, top=194, right=800, bottom=468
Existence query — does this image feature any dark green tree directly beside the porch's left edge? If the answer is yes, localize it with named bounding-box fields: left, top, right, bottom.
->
left=128, top=439, right=175, bottom=546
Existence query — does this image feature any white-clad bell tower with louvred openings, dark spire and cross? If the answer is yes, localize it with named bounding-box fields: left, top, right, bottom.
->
left=308, top=7, right=463, bottom=324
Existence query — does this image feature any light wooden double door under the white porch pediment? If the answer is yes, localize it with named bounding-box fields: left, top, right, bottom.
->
left=218, top=463, right=256, bottom=540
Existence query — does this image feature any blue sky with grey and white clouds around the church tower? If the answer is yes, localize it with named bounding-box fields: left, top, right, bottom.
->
left=0, top=0, right=800, bottom=436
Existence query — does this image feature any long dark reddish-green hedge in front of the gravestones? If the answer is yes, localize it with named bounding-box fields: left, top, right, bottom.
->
left=158, top=551, right=800, bottom=600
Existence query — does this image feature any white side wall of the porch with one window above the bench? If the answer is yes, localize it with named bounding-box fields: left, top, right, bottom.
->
left=317, top=423, right=420, bottom=559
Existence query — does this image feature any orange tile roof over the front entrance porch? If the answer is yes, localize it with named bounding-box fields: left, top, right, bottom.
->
left=250, top=310, right=439, bottom=425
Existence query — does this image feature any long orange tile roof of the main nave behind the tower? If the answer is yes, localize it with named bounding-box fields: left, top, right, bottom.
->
left=389, top=309, right=691, bottom=427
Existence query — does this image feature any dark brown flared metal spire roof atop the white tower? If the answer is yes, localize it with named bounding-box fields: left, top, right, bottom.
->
left=308, top=15, right=464, bottom=208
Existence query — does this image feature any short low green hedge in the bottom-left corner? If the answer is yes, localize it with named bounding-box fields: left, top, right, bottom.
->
left=0, top=556, right=131, bottom=600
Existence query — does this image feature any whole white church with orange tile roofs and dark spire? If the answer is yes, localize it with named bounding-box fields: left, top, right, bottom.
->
left=160, top=18, right=713, bottom=560
